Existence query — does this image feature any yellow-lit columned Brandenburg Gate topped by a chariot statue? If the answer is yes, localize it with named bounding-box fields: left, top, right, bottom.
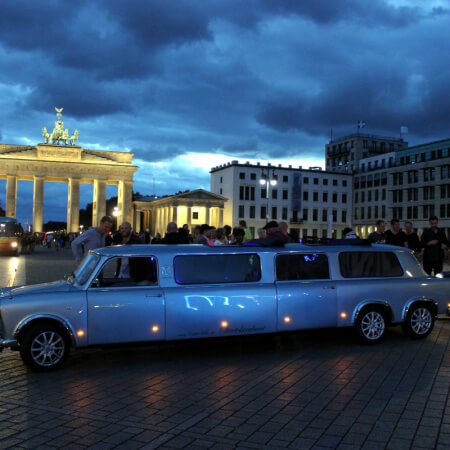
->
left=0, top=108, right=138, bottom=232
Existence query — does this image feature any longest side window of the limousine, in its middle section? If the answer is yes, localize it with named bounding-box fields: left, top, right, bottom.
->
left=174, top=253, right=261, bottom=284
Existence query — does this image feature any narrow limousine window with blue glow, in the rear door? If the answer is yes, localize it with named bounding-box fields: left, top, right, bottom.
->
left=276, top=253, right=330, bottom=281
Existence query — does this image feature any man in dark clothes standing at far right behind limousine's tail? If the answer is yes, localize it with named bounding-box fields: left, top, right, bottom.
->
left=421, top=216, right=448, bottom=275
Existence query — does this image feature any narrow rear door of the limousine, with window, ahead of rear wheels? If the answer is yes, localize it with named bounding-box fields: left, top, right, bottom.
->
left=276, top=253, right=337, bottom=331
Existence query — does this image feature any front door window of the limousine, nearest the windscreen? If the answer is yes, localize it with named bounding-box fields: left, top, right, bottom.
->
left=93, top=256, right=158, bottom=287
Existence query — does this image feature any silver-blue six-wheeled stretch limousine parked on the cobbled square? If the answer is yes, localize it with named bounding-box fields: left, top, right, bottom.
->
left=0, top=241, right=450, bottom=370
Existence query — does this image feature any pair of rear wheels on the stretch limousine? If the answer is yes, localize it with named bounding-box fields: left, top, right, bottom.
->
left=355, top=304, right=434, bottom=344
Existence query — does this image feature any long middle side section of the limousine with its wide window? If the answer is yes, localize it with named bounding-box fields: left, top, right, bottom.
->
left=164, top=253, right=276, bottom=339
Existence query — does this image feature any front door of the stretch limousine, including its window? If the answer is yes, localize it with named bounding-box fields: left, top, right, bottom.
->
left=87, top=257, right=165, bottom=345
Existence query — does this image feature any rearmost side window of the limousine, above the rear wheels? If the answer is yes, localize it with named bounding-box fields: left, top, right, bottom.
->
left=339, top=252, right=403, bottom=278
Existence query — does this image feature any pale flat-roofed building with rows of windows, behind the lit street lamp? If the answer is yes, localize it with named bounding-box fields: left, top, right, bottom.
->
left=211, top=161, right=352, bottom=237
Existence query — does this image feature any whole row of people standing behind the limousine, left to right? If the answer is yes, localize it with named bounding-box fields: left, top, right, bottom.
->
left=71, top=216, right=450, bottom=275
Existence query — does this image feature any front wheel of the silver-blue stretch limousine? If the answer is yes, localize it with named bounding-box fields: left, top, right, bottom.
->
left=20, top=324, right=69, bottom=371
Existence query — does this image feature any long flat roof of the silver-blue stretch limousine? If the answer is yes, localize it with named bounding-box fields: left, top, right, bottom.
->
left=93, top=243, right=408, bottom=256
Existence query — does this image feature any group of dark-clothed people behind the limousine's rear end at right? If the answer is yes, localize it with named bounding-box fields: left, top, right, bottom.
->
left=344, top=216, right=450, bottom=275
